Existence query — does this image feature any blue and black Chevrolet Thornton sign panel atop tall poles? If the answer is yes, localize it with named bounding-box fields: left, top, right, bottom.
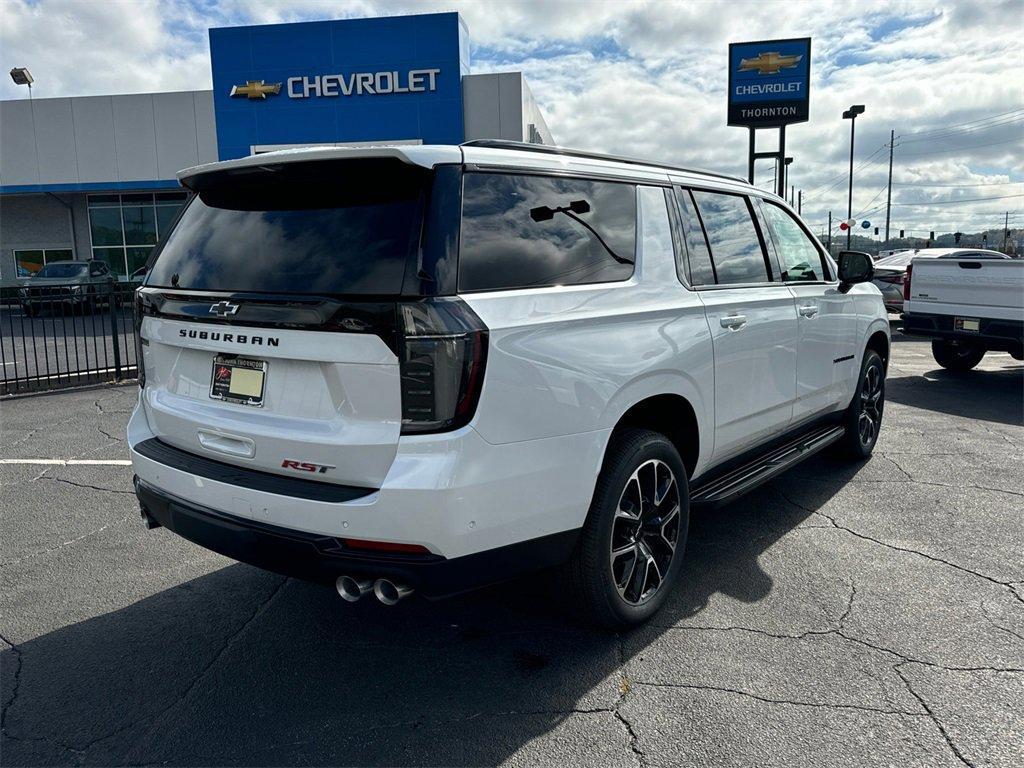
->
left=728, top=37, right=811, bottom=128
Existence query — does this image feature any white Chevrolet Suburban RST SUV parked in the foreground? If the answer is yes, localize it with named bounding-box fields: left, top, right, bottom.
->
left=128, top=141, right=889, bottom=626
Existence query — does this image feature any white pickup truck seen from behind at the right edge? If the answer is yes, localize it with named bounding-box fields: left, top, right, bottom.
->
left=903, top=256, right=1024, bottom=371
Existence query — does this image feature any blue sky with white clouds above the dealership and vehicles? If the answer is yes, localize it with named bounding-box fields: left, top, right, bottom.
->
left=0, top=0, right=1024, bottom=233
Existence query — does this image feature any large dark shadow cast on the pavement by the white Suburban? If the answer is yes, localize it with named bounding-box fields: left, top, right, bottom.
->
left=3, top=458, right=858, bottom=765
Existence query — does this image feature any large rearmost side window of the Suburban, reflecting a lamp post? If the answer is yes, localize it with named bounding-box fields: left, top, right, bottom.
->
left=459, top=173, right=637, bottom=291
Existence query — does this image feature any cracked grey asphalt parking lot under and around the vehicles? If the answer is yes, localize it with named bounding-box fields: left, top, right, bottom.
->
left=0, top=334, right=1024, bottom=766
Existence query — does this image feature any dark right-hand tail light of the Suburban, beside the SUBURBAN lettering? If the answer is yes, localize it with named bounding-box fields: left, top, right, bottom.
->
left=398, top=298, right=487, bottom=434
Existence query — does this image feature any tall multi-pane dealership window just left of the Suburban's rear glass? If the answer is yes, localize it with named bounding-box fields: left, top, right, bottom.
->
left=89, top=191, right=188, bottom=280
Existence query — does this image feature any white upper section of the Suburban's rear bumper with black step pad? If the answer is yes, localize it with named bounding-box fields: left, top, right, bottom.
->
left=128, top=393, right=610, bottom=581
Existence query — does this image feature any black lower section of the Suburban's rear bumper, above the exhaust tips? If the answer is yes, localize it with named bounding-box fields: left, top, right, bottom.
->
left=135, top=477, right=578, bottom=599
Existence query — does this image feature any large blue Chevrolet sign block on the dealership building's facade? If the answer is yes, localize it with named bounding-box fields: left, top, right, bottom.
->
left=210, top=13, right=469, bottom=160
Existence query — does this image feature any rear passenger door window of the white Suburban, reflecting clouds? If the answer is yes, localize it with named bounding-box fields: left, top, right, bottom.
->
left=693, top=189, right=770, bottom=284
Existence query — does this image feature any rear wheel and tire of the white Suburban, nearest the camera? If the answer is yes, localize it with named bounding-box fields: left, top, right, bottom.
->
left=566, top=429, right=690, bottom=629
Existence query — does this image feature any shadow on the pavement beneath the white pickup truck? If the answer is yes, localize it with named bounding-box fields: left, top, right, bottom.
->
left=886, top=366, right=1024, bottom=426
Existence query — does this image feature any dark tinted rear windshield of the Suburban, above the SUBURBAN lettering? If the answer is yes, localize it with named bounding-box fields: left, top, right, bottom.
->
left=146, top=159, right=430, bottom=295
